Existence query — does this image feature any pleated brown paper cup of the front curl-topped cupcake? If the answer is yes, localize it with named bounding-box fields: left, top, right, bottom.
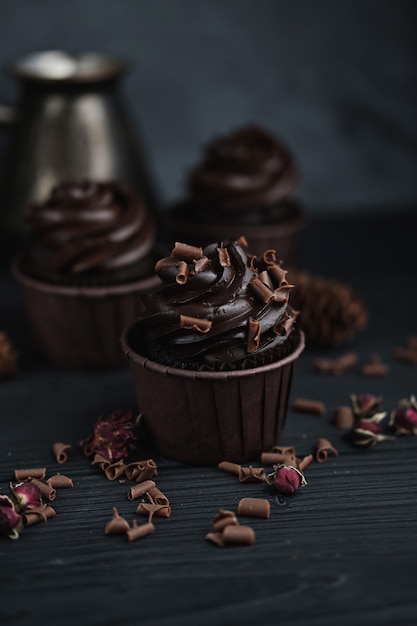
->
left=122, top=324, right=304, bottom=465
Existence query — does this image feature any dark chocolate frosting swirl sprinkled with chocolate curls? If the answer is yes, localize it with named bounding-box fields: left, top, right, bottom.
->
left=139, top=240, right=297, bottom=369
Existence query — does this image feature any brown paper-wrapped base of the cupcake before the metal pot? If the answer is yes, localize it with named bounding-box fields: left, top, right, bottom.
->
left=12, top=258, right=160, bottom=370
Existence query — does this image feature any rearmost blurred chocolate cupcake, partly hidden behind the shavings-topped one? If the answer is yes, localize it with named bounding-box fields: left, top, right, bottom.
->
left=165, top=126, right=305, bottom=265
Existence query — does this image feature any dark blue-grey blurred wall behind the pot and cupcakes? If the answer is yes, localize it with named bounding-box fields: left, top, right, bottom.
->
left=0, top=0, right=417, bottom=213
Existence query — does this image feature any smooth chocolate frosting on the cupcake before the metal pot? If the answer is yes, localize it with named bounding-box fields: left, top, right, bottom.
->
left=29, top=181, right=155, bottom=275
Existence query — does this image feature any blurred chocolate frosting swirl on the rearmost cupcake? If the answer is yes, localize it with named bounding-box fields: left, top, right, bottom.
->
left=188, top=125, right=297, bottom=213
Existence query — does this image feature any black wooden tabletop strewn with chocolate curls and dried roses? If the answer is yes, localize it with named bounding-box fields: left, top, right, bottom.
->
left=0, top=211, right=417, bottom=626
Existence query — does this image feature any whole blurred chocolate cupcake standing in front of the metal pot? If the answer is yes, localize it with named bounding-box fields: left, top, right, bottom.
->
left=13, top=181, right=159, bottom=369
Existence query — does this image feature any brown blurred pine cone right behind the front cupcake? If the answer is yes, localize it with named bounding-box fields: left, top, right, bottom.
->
left=287, top=270, right=368, bottom=348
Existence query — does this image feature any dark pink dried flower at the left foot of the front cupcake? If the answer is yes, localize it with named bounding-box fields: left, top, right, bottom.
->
left=80, top=409, right=138, bottom=462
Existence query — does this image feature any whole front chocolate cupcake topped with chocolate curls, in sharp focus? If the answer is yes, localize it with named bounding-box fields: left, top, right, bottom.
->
left=122, top=238, right=304, bottom=465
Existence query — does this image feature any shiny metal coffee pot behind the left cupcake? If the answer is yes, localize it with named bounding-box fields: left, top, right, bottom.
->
left=0, top=50, right=157, bottom=232
